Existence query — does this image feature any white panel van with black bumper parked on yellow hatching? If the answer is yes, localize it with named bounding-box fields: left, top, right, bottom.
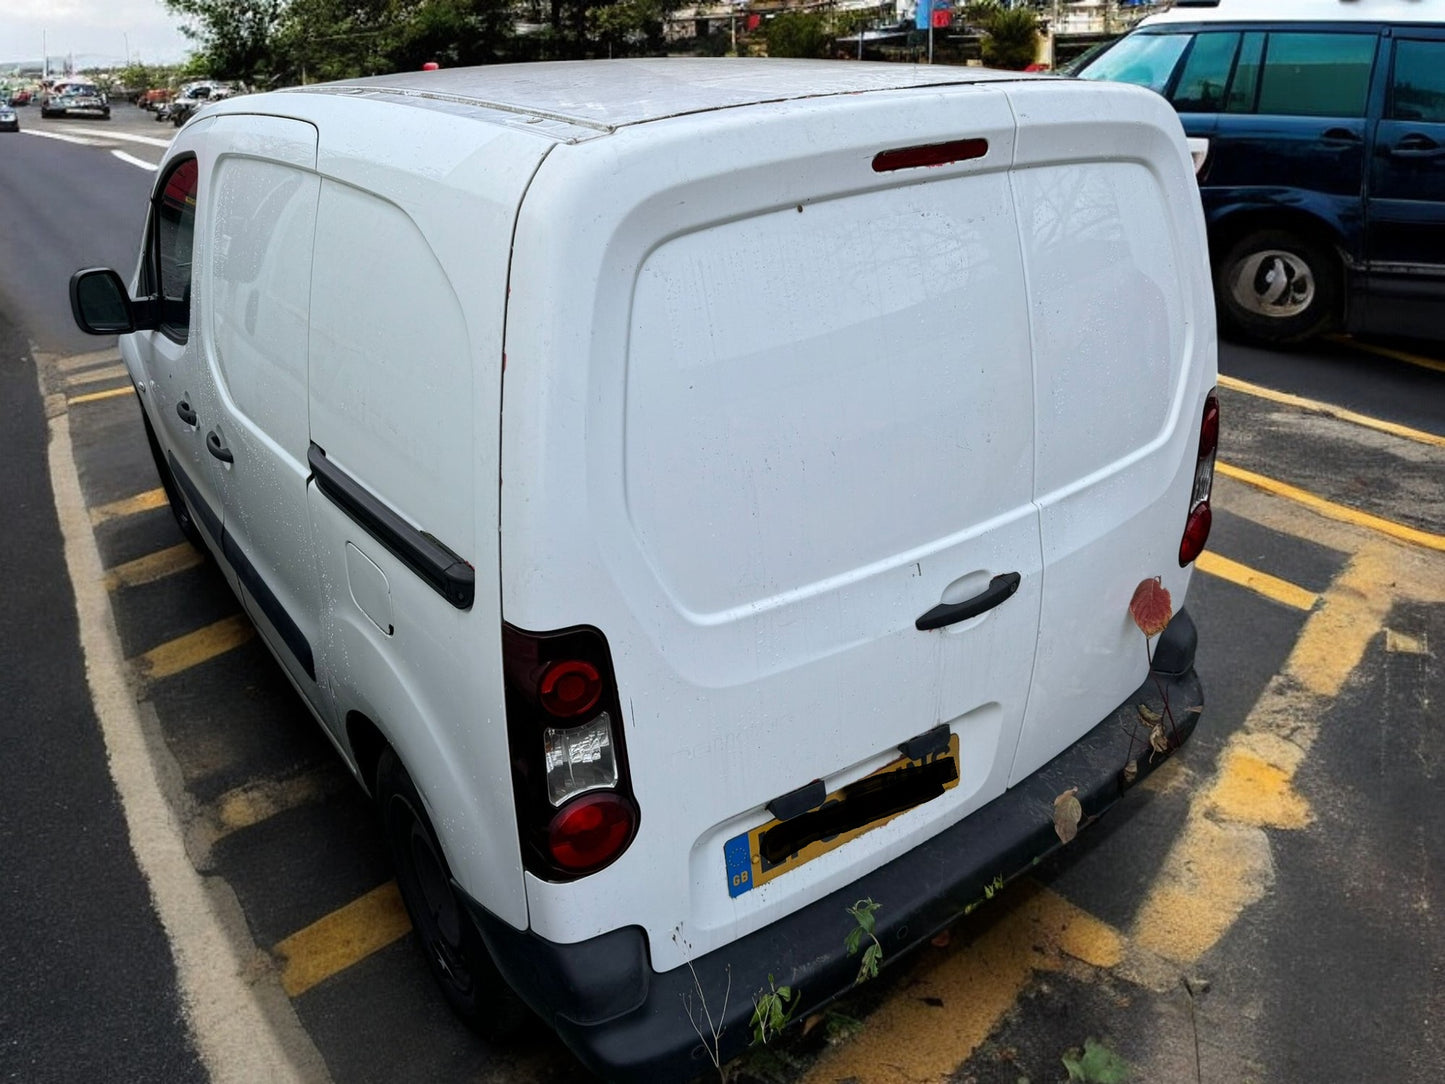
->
left=71, top=59, right=1218, bottom=1080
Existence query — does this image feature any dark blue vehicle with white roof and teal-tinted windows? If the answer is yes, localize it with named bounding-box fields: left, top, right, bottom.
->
left=1071, top=0, right=1445, bottom=343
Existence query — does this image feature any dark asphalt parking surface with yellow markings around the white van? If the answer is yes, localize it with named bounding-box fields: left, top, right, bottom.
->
left=25, top=333, right=1445, bottom=1084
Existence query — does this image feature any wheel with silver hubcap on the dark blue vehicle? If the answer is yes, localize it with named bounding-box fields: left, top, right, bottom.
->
left=1214, top=230, right=1344, bottom=345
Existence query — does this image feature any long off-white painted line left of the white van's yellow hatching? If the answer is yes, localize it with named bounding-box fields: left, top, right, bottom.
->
left=42, top=377, right=329, bottom=1084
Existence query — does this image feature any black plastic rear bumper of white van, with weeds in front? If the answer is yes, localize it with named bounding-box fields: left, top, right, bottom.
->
left=473, top=611, right=1204, bottom=1081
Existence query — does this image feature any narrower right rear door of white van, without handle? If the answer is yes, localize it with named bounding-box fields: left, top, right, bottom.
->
left=1009, top=82, right=1217, bottom=783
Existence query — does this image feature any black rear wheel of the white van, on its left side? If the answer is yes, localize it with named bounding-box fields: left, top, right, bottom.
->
left=376, top=749, right=530, bottom=1041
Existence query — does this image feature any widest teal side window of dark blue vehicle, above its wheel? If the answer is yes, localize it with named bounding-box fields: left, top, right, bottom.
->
left=1257, top=33, right=1376, bottom=117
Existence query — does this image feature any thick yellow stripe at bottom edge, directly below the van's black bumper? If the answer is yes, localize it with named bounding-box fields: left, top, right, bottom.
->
left=803, top=883, right=1124, bottom=1084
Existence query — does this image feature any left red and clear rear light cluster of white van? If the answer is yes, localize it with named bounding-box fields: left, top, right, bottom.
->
left=501, top=623, right=639, bottom=880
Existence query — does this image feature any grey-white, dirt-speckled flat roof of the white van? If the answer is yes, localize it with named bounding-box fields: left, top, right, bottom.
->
left=281, top=58, right=1039, bottom=130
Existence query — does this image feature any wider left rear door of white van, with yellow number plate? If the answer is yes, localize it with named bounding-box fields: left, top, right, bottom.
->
left=501, top=88, right=1040, bottom=968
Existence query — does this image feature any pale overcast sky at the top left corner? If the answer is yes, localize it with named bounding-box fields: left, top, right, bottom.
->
left=0, top=0, right=192, bottom=68
